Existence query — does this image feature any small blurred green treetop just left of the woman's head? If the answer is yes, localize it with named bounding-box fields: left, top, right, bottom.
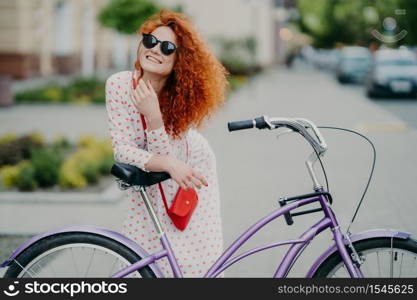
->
left=98, top=0, right=161, bottom=34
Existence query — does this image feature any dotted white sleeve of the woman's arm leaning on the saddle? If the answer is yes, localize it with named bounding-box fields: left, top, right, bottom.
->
left=105, top=74, right=152, bottom=172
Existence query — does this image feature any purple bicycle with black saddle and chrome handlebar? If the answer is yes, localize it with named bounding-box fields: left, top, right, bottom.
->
left=0, top=116, right=417, bottom=278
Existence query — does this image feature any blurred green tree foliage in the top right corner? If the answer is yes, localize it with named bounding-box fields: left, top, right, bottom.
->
left=297, top=0, right=417, bottom=48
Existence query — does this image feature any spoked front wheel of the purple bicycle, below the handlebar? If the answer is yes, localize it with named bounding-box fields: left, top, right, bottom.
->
left=313, top=237, right=417, bottom=278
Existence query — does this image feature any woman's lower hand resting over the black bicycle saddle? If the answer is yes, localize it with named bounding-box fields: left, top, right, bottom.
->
left=166, top=156, right=208, bottom=189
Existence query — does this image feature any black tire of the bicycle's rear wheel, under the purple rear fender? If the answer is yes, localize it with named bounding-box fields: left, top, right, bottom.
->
left=4, top=232, right=156, bottom=278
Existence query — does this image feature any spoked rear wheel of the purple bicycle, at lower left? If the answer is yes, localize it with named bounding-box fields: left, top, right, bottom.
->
left=4, top=232, right=156, bottom=278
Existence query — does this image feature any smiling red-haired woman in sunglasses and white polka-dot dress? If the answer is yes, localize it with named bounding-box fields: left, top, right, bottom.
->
left=106, top=10, right=227, bottom=277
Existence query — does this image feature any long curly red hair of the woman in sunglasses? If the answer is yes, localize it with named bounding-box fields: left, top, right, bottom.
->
left=135, top=9, right=228, bottom=138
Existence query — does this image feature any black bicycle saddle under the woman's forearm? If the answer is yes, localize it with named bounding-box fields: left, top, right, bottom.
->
left=110, top=162, right=171, bottom=186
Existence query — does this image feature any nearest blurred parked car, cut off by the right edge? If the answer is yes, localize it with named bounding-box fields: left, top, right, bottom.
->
left=366, top=49, right=417, bottom=97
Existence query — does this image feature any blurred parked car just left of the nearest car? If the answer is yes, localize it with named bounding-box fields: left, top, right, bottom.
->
left=335, top=46, right=372, bottom=83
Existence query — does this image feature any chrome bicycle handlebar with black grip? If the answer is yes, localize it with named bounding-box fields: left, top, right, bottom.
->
left=227, top=116, right=327, bottom=154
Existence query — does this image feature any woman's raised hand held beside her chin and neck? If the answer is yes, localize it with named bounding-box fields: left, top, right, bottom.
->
left=131, top=79, right=162, bottom=119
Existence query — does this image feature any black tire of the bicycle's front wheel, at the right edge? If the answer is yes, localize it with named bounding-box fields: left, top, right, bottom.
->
left=312, top=237, right=417, bottom=278
